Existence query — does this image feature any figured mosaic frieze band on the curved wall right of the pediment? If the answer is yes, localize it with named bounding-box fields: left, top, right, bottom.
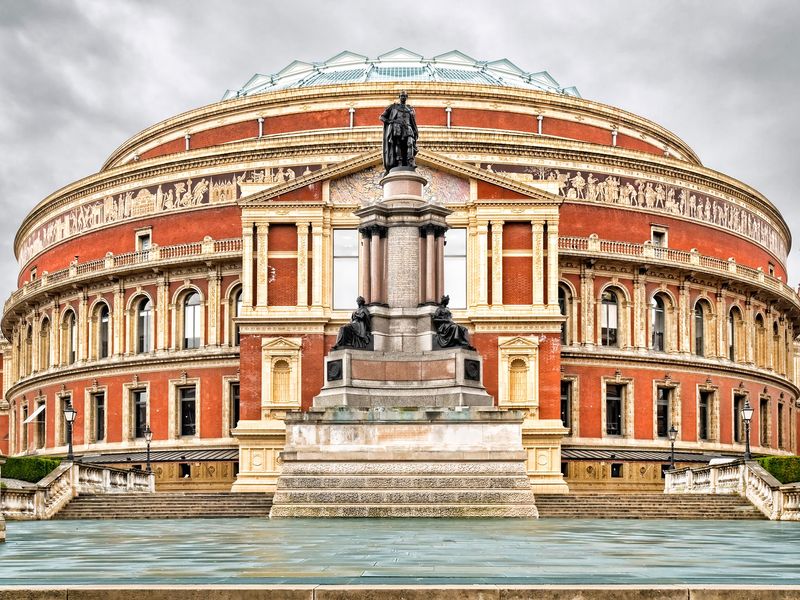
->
left=481, top=163, right=787, bottom=260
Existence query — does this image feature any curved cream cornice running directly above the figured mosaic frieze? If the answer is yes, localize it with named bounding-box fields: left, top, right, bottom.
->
left=14, top=127, right=791, bottom=255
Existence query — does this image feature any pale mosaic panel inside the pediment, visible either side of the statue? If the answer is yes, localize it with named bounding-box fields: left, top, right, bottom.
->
left=330, top=166, right=469, bottom=205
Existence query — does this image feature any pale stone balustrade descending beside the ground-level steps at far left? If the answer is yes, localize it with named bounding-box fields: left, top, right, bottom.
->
left=0, top=462, right=155, bottom=521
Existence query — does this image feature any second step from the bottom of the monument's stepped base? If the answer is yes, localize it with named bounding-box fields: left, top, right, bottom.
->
left=273, top=489, right=532, bottom=505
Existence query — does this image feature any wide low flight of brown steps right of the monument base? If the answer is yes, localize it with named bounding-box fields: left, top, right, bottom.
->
left=536, top=493, right=766, bottom=519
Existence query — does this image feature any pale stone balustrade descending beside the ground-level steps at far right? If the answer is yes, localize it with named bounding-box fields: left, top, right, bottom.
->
left=664, top=460, right=800, bottom=521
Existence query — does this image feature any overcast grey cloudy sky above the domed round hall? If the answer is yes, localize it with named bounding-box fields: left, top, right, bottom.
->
left=0, top=0, right=800, bottom=298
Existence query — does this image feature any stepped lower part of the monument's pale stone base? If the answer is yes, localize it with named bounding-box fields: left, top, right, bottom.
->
left=271, top=460, right=536, bottom=518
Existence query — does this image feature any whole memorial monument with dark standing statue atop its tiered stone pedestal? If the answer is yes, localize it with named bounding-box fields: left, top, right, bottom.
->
left=270, top=92, right=537, bottom=517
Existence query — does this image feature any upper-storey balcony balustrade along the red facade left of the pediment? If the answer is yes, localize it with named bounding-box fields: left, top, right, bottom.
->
left=4, top=236, right=242, bottom=314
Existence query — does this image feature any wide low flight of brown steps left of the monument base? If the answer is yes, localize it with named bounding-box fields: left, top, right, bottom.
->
left=53, top=492, right=272, bottom=519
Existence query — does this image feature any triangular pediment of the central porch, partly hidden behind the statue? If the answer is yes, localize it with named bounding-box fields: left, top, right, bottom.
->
left=239, top=150, right=563, bottom=207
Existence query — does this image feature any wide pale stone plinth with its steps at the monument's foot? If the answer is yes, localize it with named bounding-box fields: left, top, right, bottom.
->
left=270, top=407, right=537, bottom=518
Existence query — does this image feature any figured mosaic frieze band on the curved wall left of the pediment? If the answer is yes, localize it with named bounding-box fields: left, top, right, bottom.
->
left=19, top=165, right=321, bottom=264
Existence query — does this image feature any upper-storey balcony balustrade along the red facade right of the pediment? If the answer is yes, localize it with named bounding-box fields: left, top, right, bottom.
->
left=558, top=233, right=800, bottom=306
